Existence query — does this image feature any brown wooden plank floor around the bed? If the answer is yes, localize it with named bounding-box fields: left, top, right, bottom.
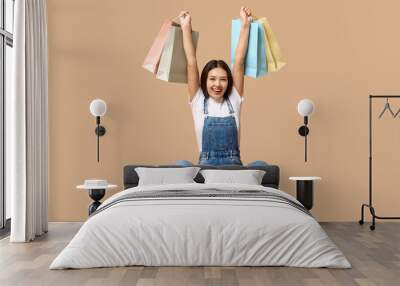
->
left=0, top=222, right=400, bottom=286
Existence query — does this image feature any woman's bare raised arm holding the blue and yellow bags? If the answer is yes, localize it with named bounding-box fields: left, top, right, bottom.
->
left=233, top=7, right=252, bottom=96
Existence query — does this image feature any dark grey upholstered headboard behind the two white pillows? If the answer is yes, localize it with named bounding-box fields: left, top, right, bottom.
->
left=124, top=165, right=279, bottom=189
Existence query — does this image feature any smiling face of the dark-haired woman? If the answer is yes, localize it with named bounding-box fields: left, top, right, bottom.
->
left=207, top=67, right=228, bottom=102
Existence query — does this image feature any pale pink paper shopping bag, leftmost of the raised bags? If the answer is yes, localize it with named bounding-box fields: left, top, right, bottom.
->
left=142, top=20, right=172, bottom=74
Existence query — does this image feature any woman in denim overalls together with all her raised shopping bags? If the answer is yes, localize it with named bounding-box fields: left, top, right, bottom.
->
left=143, top=7, right=285, bottom=166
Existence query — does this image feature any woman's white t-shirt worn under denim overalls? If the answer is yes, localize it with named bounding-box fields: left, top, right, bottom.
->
left=189, top=87, right=243, bottom=152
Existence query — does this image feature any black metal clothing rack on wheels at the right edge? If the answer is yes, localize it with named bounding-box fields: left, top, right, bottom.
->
left=358, top=95, right=400, bottom=230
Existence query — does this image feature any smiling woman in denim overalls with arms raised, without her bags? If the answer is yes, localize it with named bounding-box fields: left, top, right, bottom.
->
left=179, top=7, right=264, bottom=165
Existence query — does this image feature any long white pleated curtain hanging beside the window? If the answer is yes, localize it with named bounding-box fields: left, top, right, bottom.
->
left=6, top=0, right=48, bottom=242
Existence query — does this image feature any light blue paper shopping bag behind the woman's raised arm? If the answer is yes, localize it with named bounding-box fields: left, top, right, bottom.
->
left=231, top=19, right=268, bottom=78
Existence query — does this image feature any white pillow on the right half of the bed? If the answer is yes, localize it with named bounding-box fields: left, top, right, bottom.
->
left=200, top=170, right=265, bottom=185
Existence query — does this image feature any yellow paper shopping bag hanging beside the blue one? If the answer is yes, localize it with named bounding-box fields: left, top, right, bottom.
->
left=257, top=17, right=286, bottom=72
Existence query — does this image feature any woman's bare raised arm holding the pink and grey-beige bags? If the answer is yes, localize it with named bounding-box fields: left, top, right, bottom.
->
left=179, top=11, right=200, bottom=101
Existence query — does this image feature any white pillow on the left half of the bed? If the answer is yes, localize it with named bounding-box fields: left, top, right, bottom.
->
left=135, top=167, right=200, bottom=186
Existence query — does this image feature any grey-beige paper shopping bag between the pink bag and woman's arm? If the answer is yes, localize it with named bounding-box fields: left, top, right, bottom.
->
left=156, top=24, right=199, bottom=83
